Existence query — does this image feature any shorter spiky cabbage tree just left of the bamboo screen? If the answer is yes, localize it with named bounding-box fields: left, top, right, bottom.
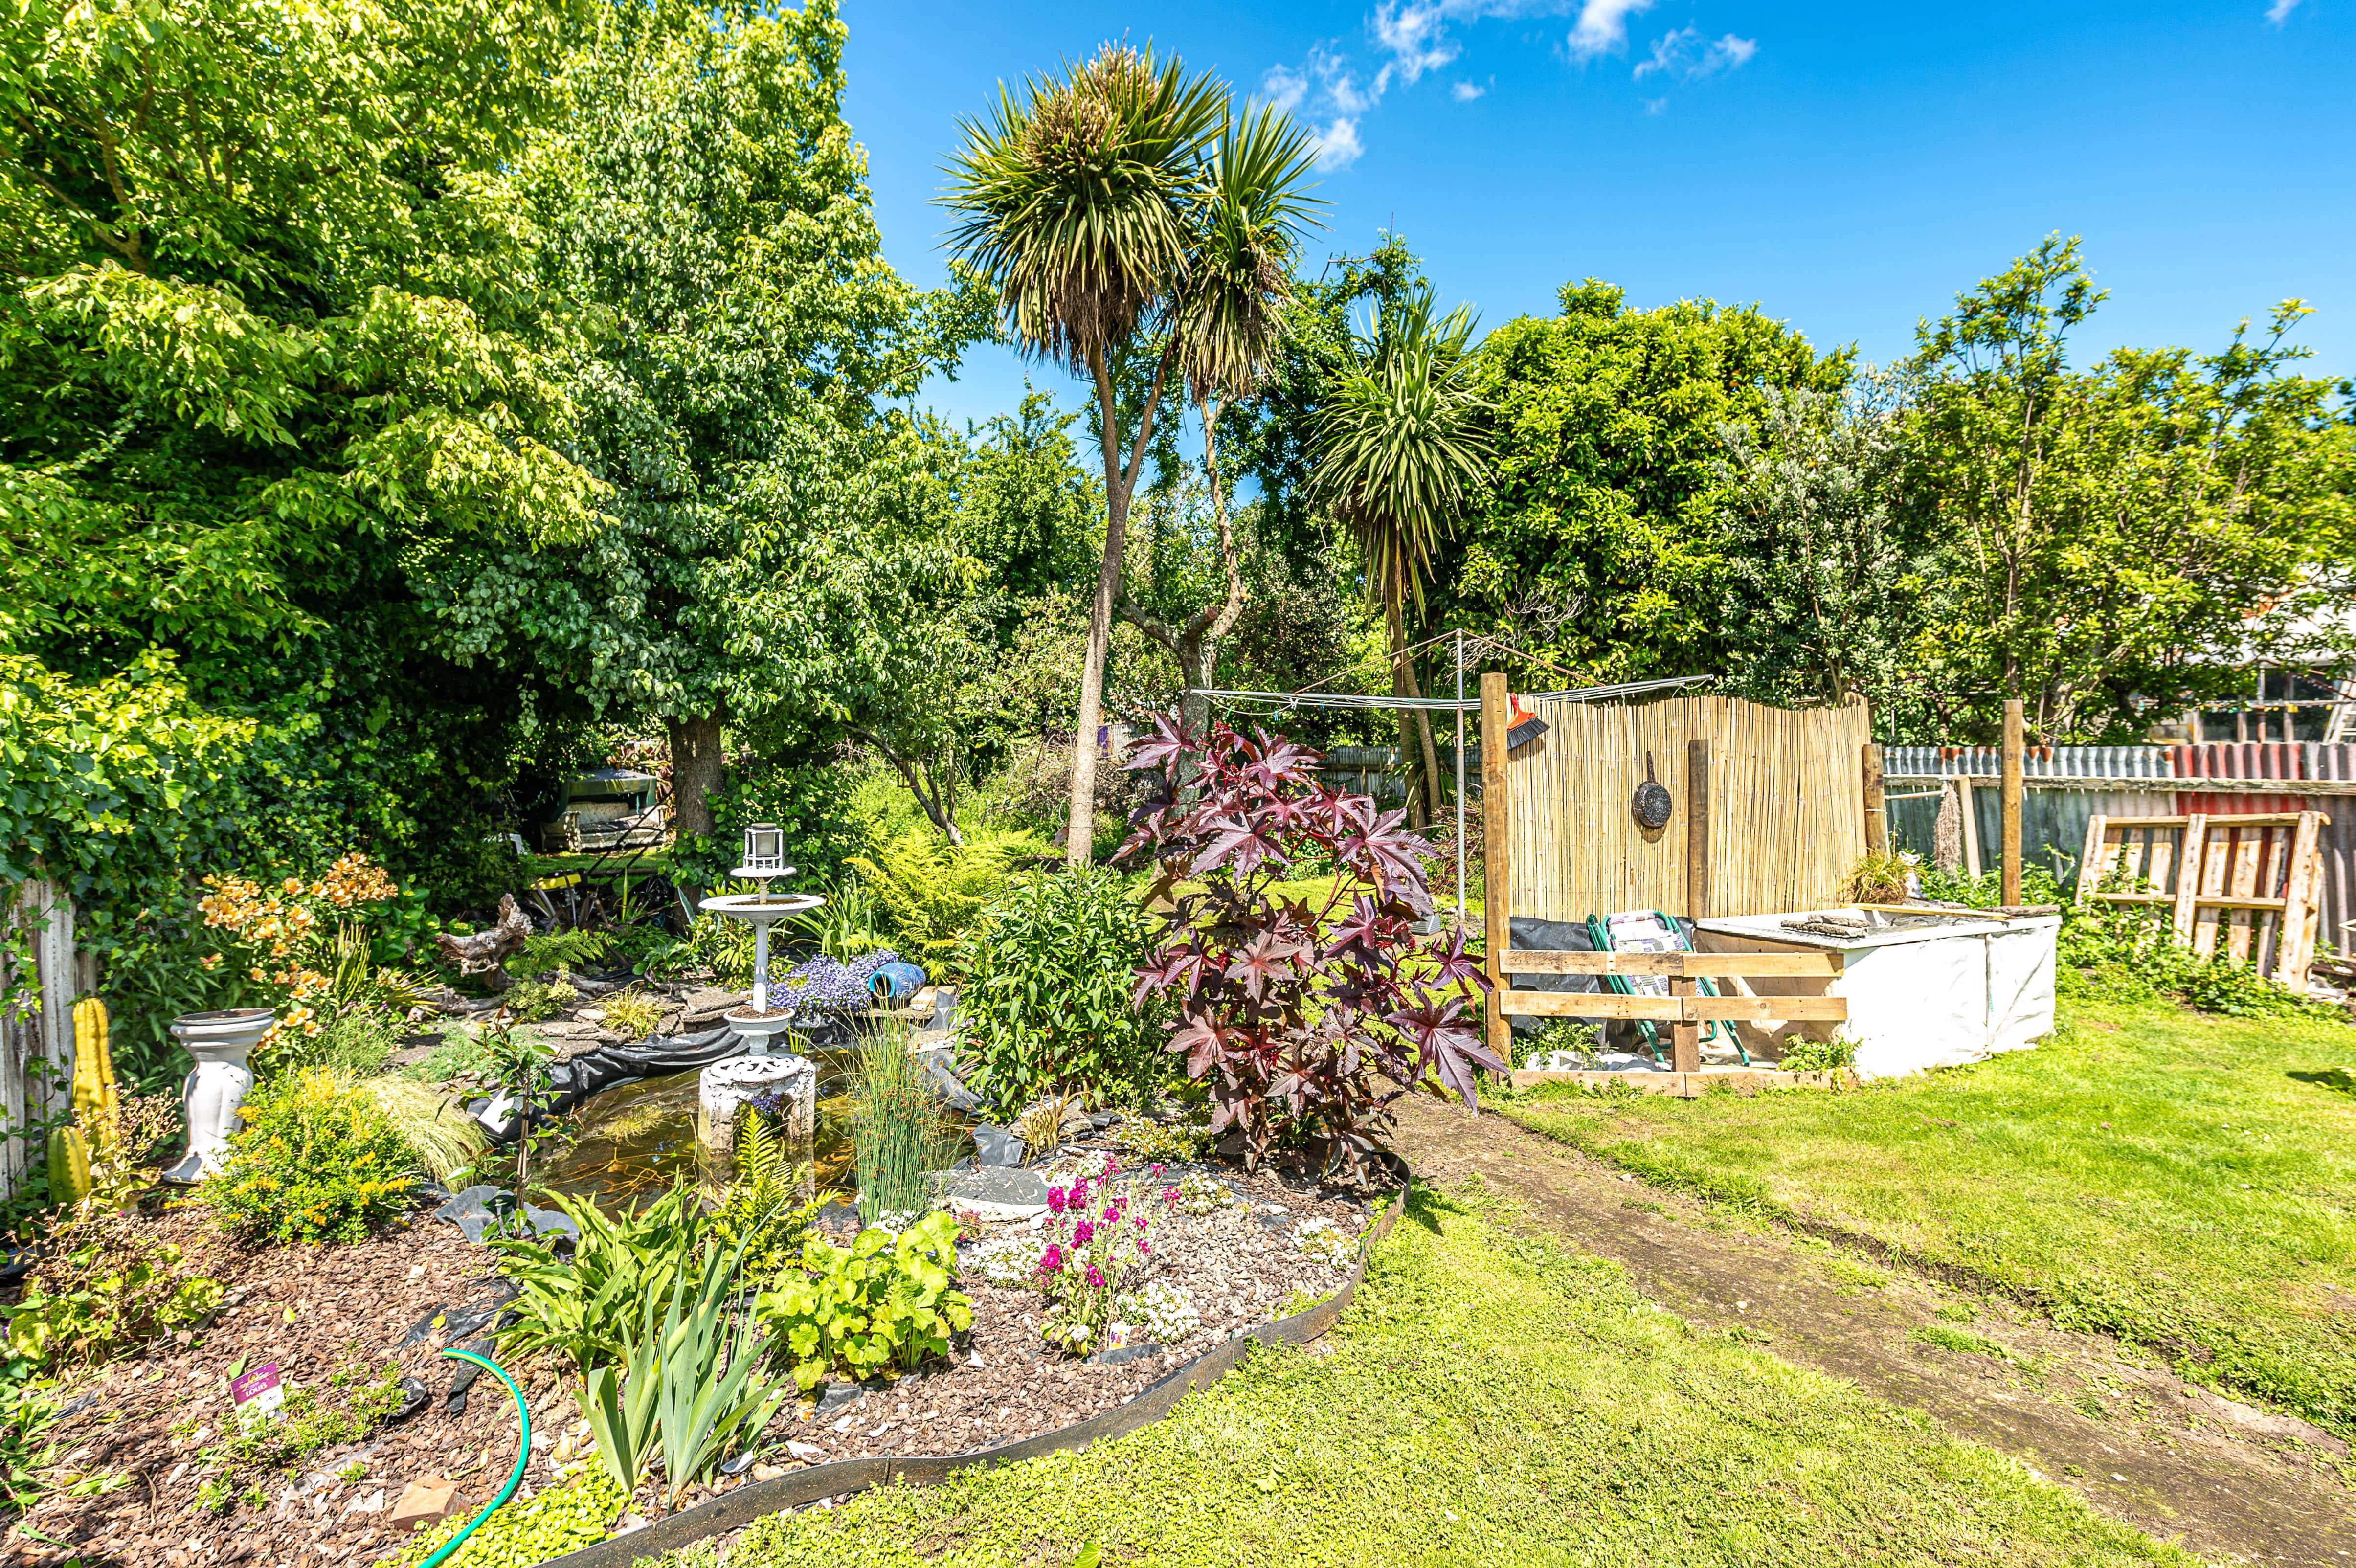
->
left=1315, top=290, right=1489, bottom=827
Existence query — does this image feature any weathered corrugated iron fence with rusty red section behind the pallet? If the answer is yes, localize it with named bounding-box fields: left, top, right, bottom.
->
left=1883, top=741, right=2356, bottom=951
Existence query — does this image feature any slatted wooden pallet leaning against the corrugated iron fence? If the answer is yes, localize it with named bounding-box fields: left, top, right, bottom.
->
left=2078, top=812, right=2330, bottom=991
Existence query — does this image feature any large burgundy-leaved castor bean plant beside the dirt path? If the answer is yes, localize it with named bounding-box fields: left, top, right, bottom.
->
left=1117, top=718, right=1505, bottom=1177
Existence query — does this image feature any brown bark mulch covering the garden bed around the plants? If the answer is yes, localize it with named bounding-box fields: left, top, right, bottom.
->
left=0, top=1154, right=1369, bottom=1568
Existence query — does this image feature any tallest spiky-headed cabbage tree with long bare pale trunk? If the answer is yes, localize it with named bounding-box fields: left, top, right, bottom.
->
left=942, top=45, right=1305, bottom=866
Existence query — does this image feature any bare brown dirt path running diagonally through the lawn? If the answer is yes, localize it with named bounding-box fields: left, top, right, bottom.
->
left=1397, top=1099, right=2356, bottom=1566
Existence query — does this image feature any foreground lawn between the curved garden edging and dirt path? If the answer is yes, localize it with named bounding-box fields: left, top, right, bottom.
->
left=674, top=1194, right=2194, bottom=1568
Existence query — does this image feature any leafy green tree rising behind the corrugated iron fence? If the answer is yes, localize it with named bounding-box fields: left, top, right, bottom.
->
left=1908, top=235, right=2356, bottom=741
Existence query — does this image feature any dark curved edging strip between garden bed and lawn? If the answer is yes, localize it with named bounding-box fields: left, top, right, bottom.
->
left=539, top=1154, right=1414, bottom=1568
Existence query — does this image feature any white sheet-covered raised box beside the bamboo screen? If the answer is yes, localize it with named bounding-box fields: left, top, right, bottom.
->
left=1694, top=909, right=2062, bottom=1078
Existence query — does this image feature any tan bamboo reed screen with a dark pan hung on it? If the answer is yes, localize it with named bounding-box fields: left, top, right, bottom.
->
left=1505, top=697, right=1873, bottom=920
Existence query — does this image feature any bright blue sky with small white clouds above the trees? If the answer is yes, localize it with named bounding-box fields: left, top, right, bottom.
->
left=843, top=0, right=2356, bottom=430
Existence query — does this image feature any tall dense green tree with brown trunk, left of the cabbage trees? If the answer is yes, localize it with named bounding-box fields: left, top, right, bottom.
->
left=410, top=0, right=975, bottom=838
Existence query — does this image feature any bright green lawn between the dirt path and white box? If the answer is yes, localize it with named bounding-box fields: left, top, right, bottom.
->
left=1501, top=1005, right=2356, bottom=1436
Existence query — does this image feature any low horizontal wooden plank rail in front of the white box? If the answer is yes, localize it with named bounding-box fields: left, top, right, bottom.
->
left=1496, top=946, right=1849, bottom=1074
